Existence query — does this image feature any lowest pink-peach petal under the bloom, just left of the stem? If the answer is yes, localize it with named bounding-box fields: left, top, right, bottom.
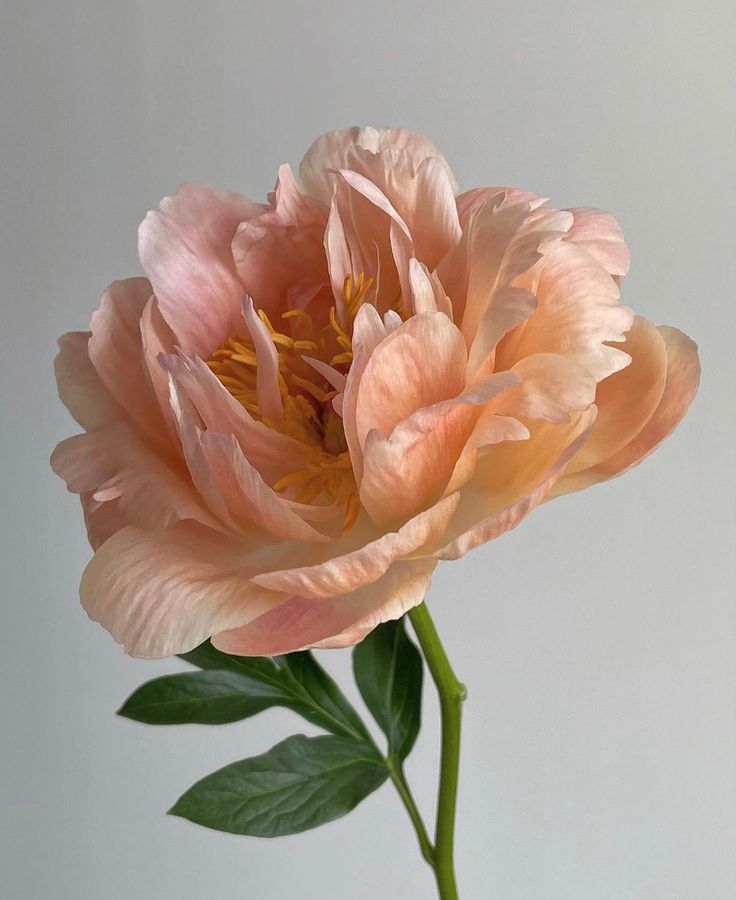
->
left=212, top=559, right=436, bottom=656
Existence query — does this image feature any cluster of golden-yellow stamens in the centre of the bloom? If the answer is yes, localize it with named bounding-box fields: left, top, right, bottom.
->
left=207, top=273, right=373, bottom=528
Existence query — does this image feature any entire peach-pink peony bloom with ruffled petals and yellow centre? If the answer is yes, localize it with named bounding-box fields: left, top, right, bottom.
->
left=52, top=128, right=699, bottom=657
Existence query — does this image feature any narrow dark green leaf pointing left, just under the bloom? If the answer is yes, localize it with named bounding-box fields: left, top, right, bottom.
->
left=118, top=669, right=283, bottom=725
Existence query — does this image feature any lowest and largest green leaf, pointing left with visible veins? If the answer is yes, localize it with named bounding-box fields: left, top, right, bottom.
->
left=169, top=734, right=388, bottom=837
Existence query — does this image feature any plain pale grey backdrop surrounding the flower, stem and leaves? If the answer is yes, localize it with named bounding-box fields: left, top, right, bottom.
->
left=0, top=0, right=736, bottom=900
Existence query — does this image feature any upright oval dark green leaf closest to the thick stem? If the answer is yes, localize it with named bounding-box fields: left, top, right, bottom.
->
left=353, top=619, right=423, bottom=761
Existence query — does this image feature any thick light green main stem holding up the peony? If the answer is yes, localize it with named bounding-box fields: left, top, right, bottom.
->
left=409, top=603, right=466, bottom=900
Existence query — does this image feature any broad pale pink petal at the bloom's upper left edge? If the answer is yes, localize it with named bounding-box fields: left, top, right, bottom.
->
left=138, top=183, right=263, bottom=359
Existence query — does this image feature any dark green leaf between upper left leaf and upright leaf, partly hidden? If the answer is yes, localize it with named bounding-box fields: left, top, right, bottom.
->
left=176, top=641, right=372, bottom=744
